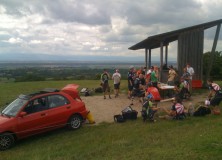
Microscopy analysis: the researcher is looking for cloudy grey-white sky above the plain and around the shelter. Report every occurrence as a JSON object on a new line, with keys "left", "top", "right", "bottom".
{"left": 0, "top": 0, "right": 222, "bottom": 61}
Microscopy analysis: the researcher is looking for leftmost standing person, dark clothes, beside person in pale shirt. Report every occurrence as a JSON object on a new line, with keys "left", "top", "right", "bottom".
{"left": 101, "top": 69, "right": 111, "bottom": 99}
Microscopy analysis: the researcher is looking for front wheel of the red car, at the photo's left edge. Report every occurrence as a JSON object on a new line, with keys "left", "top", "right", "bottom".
{"left": 0, "top": 133, "right": 15, "bottom": 150}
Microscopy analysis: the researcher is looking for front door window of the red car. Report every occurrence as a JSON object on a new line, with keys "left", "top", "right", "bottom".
{"left": 24, "top": 97, "right": 48, "bottom": 114}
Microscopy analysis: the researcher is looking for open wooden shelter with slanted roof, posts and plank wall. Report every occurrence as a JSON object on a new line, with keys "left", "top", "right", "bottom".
{"left": 129, "top": 19, "right": 222, "bottom": 81}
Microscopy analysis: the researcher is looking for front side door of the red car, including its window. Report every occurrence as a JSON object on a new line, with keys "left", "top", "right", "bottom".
{"left": 17, "top": 97, "right": 48, "bottom": 137}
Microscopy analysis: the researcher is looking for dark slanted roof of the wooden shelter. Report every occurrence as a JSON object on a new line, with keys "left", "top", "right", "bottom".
{"left": 129, "top": 19, "right": 222, "bottom": 50}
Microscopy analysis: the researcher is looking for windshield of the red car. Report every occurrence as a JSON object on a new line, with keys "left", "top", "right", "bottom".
{"left": 2, "top": 95, "right": 28, "bottom": 117}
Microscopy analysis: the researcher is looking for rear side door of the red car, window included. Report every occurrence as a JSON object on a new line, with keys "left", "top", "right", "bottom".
{"left": 43, "top": 94, "right": 72, "bottom": 128}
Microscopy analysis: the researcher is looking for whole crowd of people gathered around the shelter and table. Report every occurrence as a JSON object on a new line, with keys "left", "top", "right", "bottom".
{"left": 101, "top": 64, "right": 222, "bottom": 121}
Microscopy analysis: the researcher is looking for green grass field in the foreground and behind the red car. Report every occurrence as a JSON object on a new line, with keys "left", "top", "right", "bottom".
{"left": 0, "top": 80, "right": 222, "bottom": 160}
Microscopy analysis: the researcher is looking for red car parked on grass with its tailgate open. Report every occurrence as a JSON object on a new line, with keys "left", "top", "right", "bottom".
{"left": 0, "top": 84, "right": 88, "bottom": 150}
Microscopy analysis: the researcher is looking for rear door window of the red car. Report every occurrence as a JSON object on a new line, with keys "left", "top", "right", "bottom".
{"left": 48, "top": 94, "right": 69, "bottom": 108}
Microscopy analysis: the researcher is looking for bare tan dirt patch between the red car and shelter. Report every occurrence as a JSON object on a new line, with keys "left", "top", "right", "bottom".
{"left": 81, "top": 93, "right": 207, "bottom": 124}
